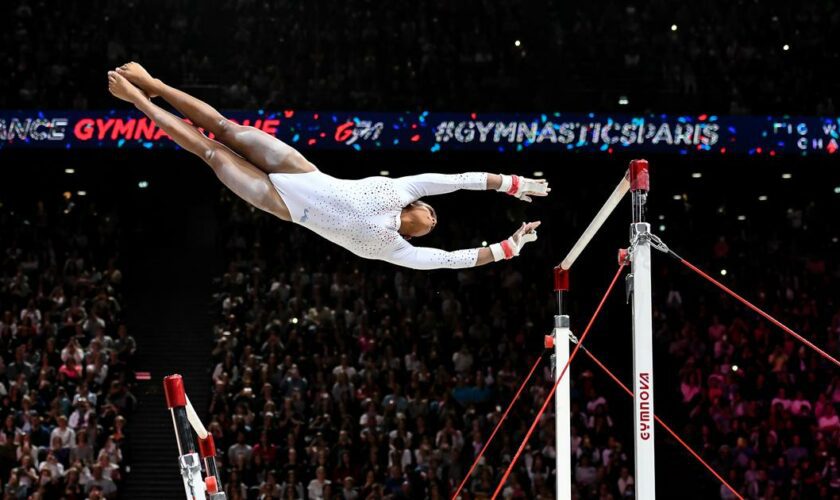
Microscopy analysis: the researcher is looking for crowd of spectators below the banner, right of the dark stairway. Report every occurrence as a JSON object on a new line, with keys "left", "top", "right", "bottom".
{"left": 200, "top": 177, "right": 840, "bottom": 500}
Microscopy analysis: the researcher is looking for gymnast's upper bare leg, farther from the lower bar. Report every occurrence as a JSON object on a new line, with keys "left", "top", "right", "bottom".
{"left": 117, "top": 62, "right": 317, "bottom": 174}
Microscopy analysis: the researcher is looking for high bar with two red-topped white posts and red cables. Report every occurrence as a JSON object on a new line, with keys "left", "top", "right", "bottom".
{"left": 451, "top": 155, "right": 840, "bottom": 500}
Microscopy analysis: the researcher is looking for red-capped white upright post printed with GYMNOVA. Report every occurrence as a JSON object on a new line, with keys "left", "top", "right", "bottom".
{"left": 630, "top": 160, "right": 656, "bottom": 499}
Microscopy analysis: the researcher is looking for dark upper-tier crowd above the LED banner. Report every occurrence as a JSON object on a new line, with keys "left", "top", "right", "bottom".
{"left": 0, "top": 0, "right": 840, "bottom": 114}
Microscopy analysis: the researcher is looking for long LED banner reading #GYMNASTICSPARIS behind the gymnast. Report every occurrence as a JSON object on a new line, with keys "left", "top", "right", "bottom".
{"left": 0, "top": 110, "right": 840, "bottom": 156}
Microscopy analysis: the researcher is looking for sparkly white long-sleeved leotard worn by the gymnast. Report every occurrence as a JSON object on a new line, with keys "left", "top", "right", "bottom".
{"left": 268, "top": 170, "right": 487, "bottom": 269}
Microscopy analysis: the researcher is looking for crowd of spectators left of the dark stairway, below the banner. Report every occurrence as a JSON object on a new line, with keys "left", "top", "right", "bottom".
{"left": 0, "top": 193, "right": 135, "bottom": 500}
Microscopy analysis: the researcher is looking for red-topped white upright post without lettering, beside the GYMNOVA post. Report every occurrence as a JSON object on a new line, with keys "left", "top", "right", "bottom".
{"left": 554, "top": 267, "right": 572, "bottom": 500}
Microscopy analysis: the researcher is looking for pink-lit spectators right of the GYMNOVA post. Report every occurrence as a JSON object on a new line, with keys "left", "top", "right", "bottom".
{"left": 655, "top": 197, "right": 840, "bottom": 499}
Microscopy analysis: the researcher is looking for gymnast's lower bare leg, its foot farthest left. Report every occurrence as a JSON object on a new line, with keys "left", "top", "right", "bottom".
{"left": 108, "top": 71, "right": 291, "bottom": 221}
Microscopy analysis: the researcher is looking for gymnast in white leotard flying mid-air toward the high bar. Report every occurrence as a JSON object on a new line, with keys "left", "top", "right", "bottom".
{"left": 108, "top": 62, "right": 551, "bottom": 269}
